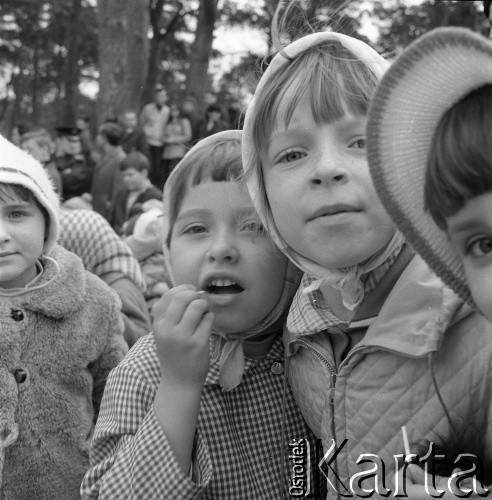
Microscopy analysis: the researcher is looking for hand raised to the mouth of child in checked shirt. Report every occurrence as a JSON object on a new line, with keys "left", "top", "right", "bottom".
{"left": 153, "top": 285, "right": 214, "bottom": 387}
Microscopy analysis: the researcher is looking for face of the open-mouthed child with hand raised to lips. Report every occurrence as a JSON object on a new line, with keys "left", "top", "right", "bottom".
{"left": 170, "top": 181, "right": 287, "bottom": 333}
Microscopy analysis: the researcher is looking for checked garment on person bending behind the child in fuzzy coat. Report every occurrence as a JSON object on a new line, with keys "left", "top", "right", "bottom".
{"left": 58, "top": 210, "right": 146, "bottom": 292}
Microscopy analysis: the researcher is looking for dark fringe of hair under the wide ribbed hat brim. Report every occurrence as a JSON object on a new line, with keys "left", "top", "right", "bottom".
{"left": 424, "top": 84, "right": 492, "bottom": 230}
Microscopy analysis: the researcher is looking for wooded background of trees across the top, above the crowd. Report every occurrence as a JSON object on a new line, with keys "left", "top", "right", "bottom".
{"left": 0, "top": 0, "right": 489, "bottom": 137}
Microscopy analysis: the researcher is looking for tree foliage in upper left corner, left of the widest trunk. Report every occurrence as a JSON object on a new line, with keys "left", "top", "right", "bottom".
{"left": 0, "top": 0, "right": 97, "bottom": 133}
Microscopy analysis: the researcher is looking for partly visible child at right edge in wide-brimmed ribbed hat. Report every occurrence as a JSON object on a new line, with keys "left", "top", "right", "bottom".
{"left": 367, "top": 27, "right": 492, "bottom": 496}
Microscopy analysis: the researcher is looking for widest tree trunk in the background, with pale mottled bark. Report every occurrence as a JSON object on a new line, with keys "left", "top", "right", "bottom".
{"left": 97, "top": 0, "right": 149, "bottom": 123}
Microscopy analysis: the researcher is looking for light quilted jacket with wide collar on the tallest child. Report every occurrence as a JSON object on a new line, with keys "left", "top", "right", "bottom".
{"left": 285, "top": 256, "right": 492, "bottom": 498}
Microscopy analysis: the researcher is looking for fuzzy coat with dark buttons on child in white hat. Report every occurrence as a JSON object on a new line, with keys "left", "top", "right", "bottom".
{"left": 0, "top": 246, "right": 127, "bottom": 500}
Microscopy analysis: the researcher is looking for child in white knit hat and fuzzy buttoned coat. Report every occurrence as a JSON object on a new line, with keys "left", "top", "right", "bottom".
{"left": 0, "top": 136, "right": 127, "bottom": 500}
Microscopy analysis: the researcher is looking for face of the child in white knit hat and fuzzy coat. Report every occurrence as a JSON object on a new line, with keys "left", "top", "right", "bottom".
{"left": 0, "top": 197, "right": 45, "bottom": 289}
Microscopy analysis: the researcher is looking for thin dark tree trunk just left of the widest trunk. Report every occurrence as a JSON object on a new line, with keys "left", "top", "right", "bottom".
{"left": 61, "top": 0, "right": 82, "bottom": 125}
